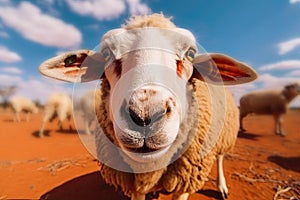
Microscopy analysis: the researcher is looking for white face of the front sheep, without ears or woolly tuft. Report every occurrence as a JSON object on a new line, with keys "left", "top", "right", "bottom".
{"left": 101, "top": 28, "right": 197, "bottom": 162}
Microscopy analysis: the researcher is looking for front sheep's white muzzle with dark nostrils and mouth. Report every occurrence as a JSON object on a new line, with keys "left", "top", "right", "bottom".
{"left": 110, "top": 84, "right": 180, "bottom": 161}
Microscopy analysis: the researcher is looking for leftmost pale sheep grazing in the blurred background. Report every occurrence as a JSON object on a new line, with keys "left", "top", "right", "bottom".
{"left": 10, "top": 96, "right": 39, "bottom": 122}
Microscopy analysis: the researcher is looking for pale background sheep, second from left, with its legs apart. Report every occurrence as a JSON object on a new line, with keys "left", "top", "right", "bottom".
{"left": 39, "top": 93, "right": 72, "bottom": 137}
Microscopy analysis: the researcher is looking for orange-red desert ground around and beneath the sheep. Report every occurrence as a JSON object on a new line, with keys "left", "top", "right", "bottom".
{"left": 0, "top": 109, "right": 300, "bottom": 200}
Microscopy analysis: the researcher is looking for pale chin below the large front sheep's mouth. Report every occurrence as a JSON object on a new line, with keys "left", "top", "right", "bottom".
{"left": 122, "top": 145, "right": 171, "bottom": 163}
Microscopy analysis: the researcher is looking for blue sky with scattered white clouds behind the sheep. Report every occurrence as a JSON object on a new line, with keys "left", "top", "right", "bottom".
{"left": 0, "top": 0, "right": 300, "bottom": 106}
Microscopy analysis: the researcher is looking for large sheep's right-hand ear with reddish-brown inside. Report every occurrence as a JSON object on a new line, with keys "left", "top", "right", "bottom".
{"left": 192, "top": 54, "right": 257, "bottom": 85}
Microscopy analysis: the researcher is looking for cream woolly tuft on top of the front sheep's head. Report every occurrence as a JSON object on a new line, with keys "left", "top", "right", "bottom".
{"left": 122, "top": 13, "right": 176, "bottom": 30}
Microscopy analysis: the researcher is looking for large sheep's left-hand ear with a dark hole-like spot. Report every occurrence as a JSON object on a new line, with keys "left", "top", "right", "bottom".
{"left": 39, "top": 49, "right": 106, "bottom": 83}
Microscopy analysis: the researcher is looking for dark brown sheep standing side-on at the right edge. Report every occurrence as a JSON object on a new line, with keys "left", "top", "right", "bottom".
{"left": 240, "top": 82, "right": 300, "bottom": 136}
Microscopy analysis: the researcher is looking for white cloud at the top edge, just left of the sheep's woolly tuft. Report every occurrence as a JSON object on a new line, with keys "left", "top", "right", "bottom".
{"left": 67, "top": 0, "right": 150, "bottom": 20}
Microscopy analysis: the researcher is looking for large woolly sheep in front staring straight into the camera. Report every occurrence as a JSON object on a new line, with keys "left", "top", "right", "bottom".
{"left": 39, "top": 14, "right": 257, "bottom": 200}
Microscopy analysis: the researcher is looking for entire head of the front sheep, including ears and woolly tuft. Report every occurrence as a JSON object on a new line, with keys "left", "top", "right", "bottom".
{"left": 40, "top": 14, "right": 256, "bottom": 172}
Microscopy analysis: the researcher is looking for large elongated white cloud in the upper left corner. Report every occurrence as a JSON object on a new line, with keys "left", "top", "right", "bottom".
{"left": 0, "top": 1, "right": 82, "bottom": 48}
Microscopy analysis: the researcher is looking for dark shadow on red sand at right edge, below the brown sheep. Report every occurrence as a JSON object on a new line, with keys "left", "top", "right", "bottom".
{"left": 268, "top": 155, "right": 300, "bottom": 172}
